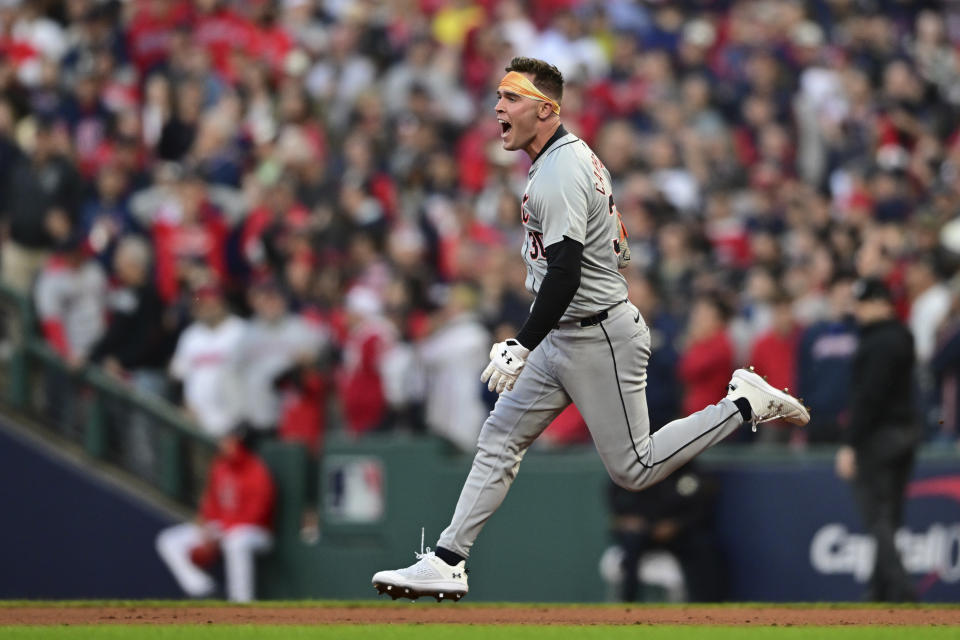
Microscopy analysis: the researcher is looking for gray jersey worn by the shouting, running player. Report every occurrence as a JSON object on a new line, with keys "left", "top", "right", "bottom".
{"left": 521, "top": 133, "right": 627, "bottom": 321}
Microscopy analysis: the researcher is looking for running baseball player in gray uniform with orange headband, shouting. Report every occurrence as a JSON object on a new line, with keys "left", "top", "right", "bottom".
{"left": 373, "top": 58, "right": 809, "bottom": 601}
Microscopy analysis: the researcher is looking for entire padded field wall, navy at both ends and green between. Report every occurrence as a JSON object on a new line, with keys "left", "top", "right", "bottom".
{"left": 0, "top": 416, "right": 960, "bottom": 602}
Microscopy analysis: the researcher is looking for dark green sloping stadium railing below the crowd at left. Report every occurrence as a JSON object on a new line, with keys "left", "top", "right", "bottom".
{"left": 0, "top": 283, "right": 216, "bottom": 507}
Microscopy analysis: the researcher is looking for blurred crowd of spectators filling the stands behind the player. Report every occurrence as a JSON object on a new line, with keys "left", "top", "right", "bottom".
{"left": 0, "top": 0, "right": 960, "bottom": 451}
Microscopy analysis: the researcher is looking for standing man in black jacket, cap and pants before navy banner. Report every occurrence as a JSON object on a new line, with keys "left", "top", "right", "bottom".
{"left": 836, "top": 279, "right": 920, "bottom": 602}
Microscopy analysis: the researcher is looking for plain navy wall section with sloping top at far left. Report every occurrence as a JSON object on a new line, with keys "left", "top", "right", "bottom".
{"left": 0, "top": 420, "right": 182, "bottom": 599}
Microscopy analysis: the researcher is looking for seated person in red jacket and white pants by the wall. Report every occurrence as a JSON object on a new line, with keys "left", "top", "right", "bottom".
{"left": 157, "top": 427, "right": 276, "bottom": 602}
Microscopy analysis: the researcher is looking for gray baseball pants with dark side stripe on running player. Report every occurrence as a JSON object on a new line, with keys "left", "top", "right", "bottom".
{"left": 437, "top": 303, "right": 743, "bottom": 557}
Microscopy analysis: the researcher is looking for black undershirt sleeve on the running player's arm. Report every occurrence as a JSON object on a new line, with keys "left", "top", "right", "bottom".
{"left": 516, "top": 236, "right": 583, "bottom": 351}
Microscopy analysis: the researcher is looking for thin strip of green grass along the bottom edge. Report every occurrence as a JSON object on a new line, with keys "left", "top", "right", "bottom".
{"left": 0, "top": 625, "right": 960, "bottom": 640}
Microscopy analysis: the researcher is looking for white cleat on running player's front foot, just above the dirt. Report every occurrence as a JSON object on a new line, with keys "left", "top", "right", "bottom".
{"left": 372, "top": 547, "right": 468, "bottom": 602}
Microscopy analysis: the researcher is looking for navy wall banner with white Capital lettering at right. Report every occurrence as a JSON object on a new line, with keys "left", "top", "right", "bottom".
{"left": 716, "top": 461, "right": 960, "bottom": 602}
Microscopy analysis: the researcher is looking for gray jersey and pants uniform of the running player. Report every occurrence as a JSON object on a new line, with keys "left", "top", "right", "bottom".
{"left": 438, "top": 129, "right": 743, "bottom": 557}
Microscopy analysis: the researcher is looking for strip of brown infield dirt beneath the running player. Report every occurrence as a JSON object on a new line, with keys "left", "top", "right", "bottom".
{"left": 0, "top": 602, "right": 960, "bottom": 627}
